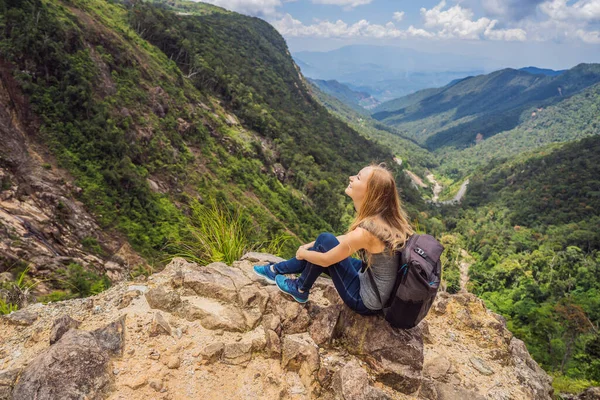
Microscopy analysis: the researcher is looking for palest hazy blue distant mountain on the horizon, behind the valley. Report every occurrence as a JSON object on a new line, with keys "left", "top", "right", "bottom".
{"left": 293, "top": 45, "right": 500, "bottom": 101}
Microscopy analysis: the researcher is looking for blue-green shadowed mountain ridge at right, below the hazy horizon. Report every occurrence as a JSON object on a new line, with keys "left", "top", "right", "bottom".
{"left": 373, "top": 64, "right": 600, "bottom": 149}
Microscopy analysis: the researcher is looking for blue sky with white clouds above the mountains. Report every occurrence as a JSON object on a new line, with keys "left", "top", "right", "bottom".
{"left": 203, "top": 0, "right": 600, "bottom": 69}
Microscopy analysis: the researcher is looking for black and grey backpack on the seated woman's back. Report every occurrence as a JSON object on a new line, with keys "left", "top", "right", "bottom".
{"left": 367, "top": 234, "right": 444, "bottom": 329}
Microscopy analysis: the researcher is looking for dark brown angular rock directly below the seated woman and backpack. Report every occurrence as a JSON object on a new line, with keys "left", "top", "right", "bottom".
{"left": 334, "top": 306, "right": 423, "bottom": 394}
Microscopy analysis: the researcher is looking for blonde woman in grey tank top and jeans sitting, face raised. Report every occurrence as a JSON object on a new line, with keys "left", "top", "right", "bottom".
{"left": 254, "top": 165, "right": 413, "bottom": 314}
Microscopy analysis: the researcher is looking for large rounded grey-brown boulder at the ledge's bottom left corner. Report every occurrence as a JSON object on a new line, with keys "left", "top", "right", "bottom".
{"left": 13, "top": 329, "right": 114, "bottom": 400}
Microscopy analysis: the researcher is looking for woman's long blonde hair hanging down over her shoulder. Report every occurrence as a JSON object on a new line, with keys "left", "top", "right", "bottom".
{"left": 348, "top": 164, "right": 414, "bottom": 266}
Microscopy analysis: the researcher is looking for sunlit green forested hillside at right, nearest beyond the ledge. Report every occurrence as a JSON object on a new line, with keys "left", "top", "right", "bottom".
{"left": 444, "top": 136, "right": 600, "bottom": 381}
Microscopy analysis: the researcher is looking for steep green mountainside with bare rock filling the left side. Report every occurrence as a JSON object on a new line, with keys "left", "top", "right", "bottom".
{"left": 0, "top": 0, "right": 393, "bottom": 300}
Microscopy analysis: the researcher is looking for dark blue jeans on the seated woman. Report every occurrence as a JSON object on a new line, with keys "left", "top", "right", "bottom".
{"left": 273, "top": 233, "right": 378, "bottom": 315}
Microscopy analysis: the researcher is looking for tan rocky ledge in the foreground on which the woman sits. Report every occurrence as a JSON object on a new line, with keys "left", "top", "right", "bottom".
{"left": 0, "top": 253, "right": 552, "bottom": 400}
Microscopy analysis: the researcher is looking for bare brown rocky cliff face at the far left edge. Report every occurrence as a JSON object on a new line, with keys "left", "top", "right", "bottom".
{"left": 0, "top": 63, "right": 144, "bottom": 294}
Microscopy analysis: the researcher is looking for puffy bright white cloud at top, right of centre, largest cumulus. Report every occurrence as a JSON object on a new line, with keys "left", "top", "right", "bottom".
{"left": 421, "top": 0, "right": 527, "bottom": 41}
